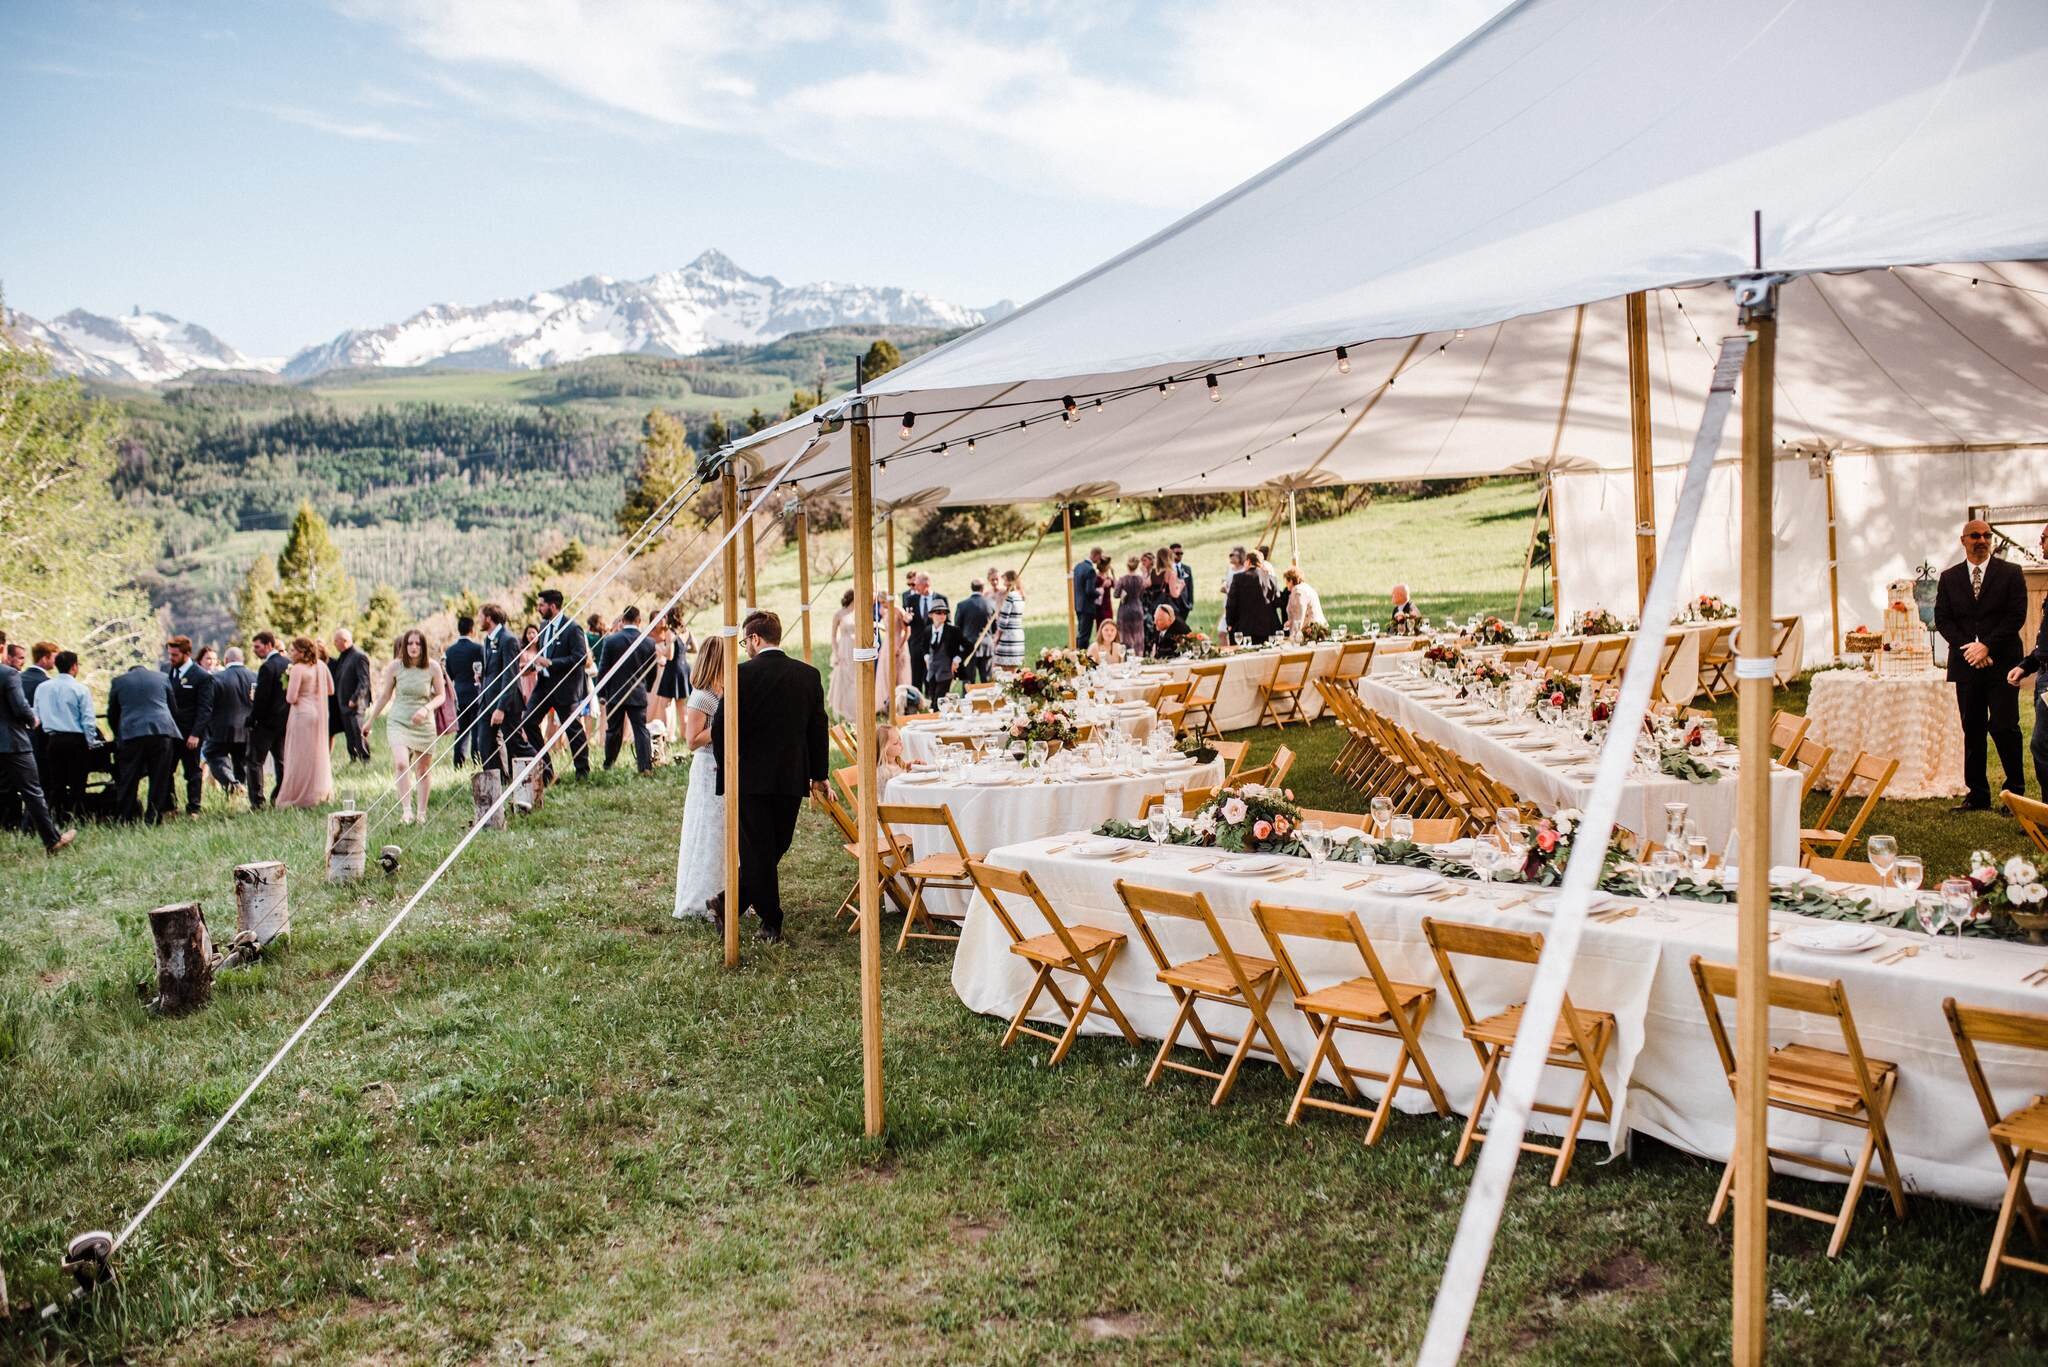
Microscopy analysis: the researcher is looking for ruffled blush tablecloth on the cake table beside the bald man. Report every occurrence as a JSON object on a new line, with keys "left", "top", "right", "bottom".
{"left": 1806, "top": 670, "right": 1970, "bottom": 797}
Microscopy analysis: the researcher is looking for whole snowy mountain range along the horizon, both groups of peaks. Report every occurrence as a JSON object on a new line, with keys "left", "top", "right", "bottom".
{"left": 4, "top": 250, "right": 1012, "bottom": 385}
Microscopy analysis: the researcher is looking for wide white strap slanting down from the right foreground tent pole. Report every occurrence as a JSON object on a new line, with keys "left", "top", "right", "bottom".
{"left": 1417, "top": 334, "right": 1757, "bottom": 1367}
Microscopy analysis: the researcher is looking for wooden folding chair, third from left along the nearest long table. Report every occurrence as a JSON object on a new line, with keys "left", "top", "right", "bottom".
{"left": 1251, "top": 902, "right": 1450, "bottom": 1148}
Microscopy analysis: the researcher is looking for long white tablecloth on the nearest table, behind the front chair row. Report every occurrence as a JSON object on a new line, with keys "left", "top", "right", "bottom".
{"left": 952, "top": 840, "right": 2048, "bottom": 1205}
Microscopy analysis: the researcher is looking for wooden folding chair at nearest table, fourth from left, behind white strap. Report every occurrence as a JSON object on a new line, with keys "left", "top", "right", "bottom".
{"left": 1421, "top": 916, "right": 1614, "bottom": 1187}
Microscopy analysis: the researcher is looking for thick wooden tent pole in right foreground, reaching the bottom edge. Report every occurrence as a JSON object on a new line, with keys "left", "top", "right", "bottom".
{"left": 1733, "top": 285, "right": 1778, "bottom": 1363}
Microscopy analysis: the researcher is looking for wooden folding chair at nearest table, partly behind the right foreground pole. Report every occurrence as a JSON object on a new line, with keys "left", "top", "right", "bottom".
{"left": 1692, "top": 955, "right": 1907, "bottom": 1258}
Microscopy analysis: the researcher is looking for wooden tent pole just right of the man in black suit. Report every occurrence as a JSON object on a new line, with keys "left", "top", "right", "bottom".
{"left": 843, "top": 404, "right": 883, "bottom": 1140}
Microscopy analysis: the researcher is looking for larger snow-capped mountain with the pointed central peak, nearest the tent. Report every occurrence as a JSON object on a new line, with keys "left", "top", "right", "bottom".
{"left": 285, "top": 250, "right": 985, "bottom": 379}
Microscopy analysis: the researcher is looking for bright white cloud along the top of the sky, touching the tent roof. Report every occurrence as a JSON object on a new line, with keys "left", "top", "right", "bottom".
{"left": 338, "top": 0, "right": 1499, "bottom": 207}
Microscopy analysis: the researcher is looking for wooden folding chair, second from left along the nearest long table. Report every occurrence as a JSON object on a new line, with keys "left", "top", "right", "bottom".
{"left": 1116, "top": 879, "right": 1294, "bottom": 1107}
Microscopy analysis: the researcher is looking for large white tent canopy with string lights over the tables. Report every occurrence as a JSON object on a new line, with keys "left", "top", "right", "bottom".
{"left": 745, "top": 0, "right": 2048, "bottom": 512}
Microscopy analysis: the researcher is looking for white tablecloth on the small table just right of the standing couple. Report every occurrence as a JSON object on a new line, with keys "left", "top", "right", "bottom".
{"left": 883, "top": 758, "right": 1223, "bottom": 914}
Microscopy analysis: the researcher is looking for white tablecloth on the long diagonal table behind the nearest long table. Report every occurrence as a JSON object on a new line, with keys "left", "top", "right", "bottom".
{"left": 1358, "top": 678, "right": 1800, "bottom": 865}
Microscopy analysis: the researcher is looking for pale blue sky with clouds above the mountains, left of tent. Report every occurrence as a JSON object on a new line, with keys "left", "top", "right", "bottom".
{"left": 0, "top": 0, "right": 1497, "bottom": 355}
